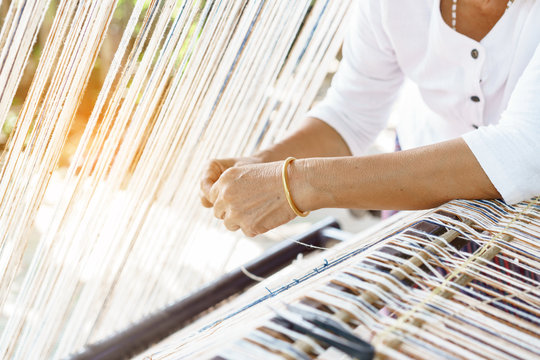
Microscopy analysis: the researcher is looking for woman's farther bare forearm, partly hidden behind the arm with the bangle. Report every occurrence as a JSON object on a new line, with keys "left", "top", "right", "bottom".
{"left": 254, "top": 118, "right": 351, "bottom": 162}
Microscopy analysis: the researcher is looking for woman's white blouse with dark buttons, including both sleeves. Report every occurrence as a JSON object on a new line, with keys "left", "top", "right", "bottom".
{"left": 308, "top": 0, "right": 540, "bottom": 203}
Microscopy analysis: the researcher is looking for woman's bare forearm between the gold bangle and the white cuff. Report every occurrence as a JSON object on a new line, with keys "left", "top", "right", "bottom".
{"left": 289, "top": 139, "right": 500, "bottom": 210}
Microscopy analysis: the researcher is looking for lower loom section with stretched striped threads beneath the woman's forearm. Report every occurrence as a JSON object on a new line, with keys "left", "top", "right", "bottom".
{"left": 140, "top": 198, "right": 540, "bottom": 360}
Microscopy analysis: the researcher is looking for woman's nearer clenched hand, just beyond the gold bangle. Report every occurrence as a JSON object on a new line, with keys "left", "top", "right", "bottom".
{"left": 209, "top": 162, "right": 295, "bottom": 237}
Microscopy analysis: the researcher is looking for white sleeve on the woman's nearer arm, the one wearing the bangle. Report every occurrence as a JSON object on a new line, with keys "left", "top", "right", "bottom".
{"left": 463, "top": 46, "right": 540, "bottom": 204}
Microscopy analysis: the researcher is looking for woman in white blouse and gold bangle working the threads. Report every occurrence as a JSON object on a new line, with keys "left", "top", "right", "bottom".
{"left": 201, "top": 0, "right": 540, "bottom": 236}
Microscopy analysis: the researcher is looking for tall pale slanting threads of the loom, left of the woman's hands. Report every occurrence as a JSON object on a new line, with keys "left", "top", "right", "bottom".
{"left": 0, "top": 0, "right": 349, "bottom": 359}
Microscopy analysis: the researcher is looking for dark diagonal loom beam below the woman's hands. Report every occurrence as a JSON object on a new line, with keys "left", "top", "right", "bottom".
{"left": 69, "top": 218, "right": 342, "bottom": 360}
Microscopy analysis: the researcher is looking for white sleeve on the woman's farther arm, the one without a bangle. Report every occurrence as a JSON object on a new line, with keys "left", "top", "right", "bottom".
{"left": 307, "top": 0, "right": 403, "bottom": 155}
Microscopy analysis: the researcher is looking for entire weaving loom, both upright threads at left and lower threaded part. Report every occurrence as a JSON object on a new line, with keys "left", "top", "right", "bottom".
{"left": 0, "top": 0, "right": 540, "bottom": 359}
